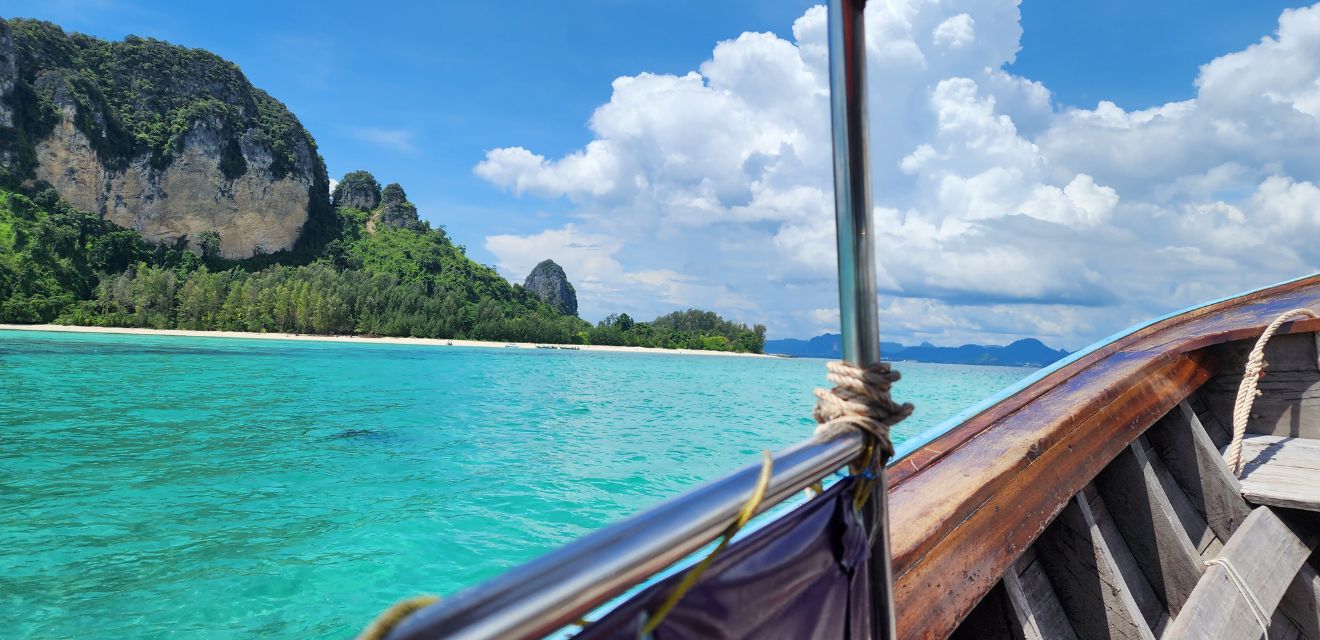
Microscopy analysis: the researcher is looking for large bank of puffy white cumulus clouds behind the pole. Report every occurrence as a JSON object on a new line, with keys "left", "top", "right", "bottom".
{"left": 475, "top": 0, "right": 1320, "bottom": 348}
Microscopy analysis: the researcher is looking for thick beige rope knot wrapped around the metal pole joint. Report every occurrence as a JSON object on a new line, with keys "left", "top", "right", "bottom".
{"left": 812, "top": 362, "right": 912, "bottom": 458}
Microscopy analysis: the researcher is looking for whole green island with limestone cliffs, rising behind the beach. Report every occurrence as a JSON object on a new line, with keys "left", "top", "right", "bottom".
{"left": 0, "top": 18, "right": 766, "bottom": 352}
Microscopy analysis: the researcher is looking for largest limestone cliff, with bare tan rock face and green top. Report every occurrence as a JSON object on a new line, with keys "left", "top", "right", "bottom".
{"left": 0, "top": 20, "right": 333, "bottom": 259}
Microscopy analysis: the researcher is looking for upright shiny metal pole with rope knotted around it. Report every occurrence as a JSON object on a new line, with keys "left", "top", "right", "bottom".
{"left": 829, "top": 0, "right": 896, "bottom": 640}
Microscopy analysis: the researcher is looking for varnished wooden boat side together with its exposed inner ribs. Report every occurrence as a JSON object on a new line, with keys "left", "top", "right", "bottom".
{"left": 908, "top": 276, "right": 1320, "bottom": 640}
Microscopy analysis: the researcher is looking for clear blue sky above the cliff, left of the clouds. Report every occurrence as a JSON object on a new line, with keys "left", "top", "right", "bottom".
{"left": 0, "top": 0, "right": 810, "bottom": 255}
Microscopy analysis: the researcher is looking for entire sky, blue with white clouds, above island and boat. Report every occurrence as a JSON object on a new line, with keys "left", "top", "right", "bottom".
{"left": 3, "top": 0, "right": 1320, "bottom": 348}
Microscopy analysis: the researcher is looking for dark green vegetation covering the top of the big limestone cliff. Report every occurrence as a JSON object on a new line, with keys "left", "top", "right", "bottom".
{"left": 0, "top": 18, "right": 315, "bottom": 179}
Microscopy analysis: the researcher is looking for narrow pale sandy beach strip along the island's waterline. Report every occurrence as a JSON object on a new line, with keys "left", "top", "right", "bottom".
{"left": 0, "top": 323, "right": 779, "bottom": 359}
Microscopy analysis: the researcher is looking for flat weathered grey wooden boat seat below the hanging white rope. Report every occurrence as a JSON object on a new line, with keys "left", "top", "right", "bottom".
{"left": 1241, "top": 434, "right": 1320, "bottom": 511}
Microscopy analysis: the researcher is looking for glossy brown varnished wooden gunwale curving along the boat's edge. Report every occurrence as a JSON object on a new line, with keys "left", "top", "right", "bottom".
{"left": 890, "top": 274, "right": 1320, "bottom": 637}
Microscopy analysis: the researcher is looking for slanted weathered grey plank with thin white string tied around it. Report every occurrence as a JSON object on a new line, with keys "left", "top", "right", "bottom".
{"left": 1164, "top": 507, "right": 1320, "bottom": 640}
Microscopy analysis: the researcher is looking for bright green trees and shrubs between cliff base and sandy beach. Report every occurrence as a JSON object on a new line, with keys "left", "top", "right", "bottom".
{"left": 0, "top": 183, "right": 766, "bottom": 352}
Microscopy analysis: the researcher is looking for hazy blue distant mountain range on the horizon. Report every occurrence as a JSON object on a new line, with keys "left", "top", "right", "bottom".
{"left": 766, "top": 334, "right": 1068, "bottom": 367}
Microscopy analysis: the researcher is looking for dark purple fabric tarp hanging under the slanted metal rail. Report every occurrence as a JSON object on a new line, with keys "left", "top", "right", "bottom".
{"left": 576, "top": 478, "right": 870, "bottom": 640}
